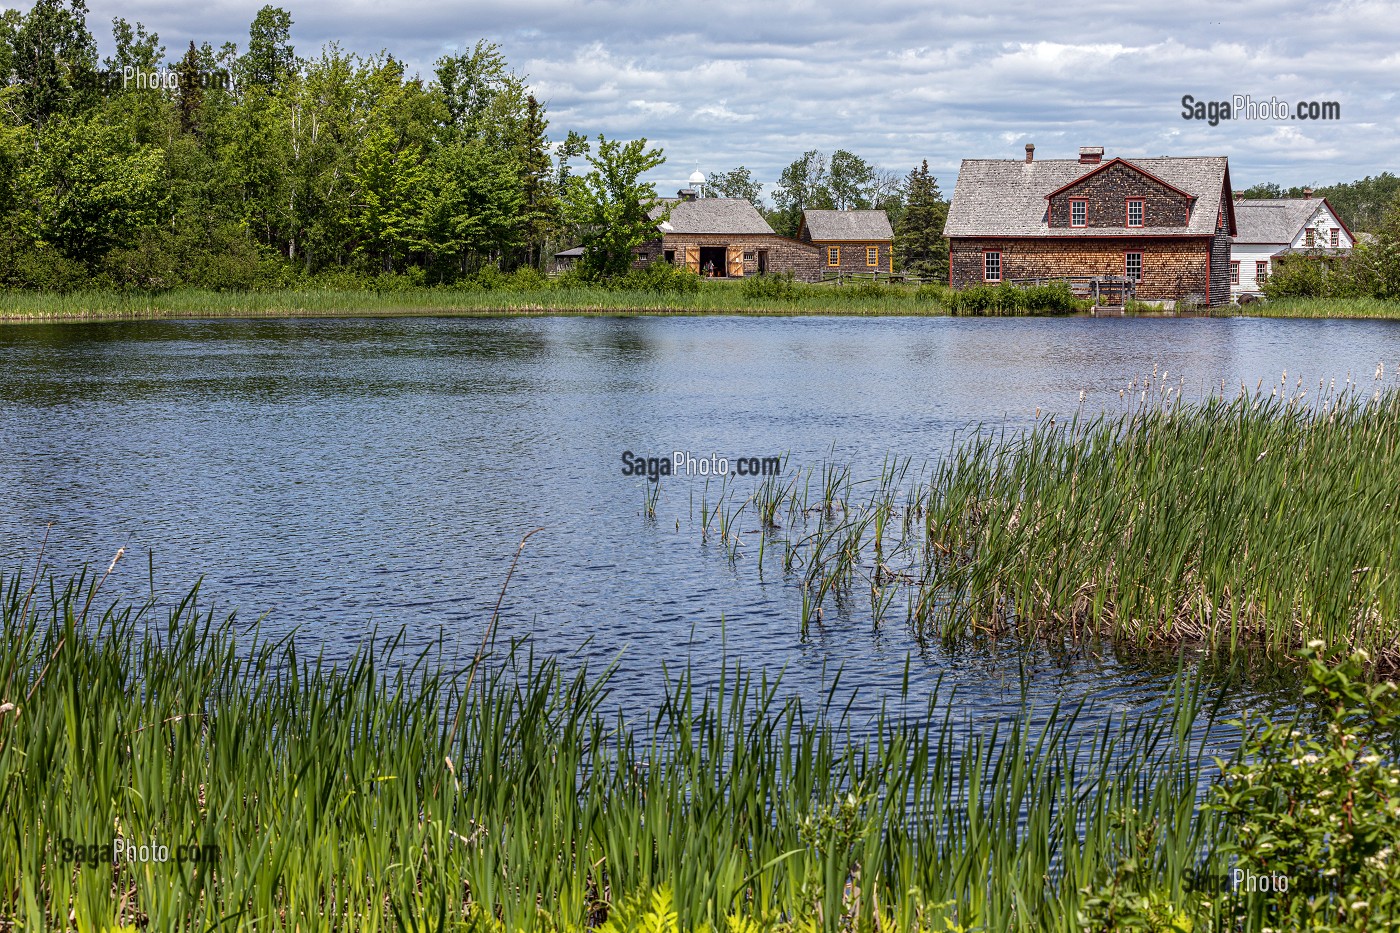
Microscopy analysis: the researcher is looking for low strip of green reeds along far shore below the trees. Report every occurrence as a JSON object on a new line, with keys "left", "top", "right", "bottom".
{"left": 0, "top": 282, "right": 946, "bottom": 321}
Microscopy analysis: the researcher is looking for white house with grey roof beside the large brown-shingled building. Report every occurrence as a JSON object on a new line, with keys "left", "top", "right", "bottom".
{"left": 1229, "top": 189, "right": 1357, "bottom": 298}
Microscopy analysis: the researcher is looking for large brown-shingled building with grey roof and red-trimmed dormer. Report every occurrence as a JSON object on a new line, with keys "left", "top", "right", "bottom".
{"left": 944, "top": 146, "right": 1235, "bottom": 305}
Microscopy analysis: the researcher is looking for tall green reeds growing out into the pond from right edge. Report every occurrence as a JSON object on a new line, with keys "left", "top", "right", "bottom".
{"left": 714, "top": 370, "right": 1400, "bottom": 675}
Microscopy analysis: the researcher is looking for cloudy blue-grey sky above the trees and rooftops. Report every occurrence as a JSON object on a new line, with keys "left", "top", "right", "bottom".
{"left": 76, "top": 0, "right": 1400, "bottom": 201}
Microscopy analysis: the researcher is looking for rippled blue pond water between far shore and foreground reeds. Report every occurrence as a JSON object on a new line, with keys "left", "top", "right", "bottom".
{"left": 0, "top": 317, "right": 1400, "bottom": 720}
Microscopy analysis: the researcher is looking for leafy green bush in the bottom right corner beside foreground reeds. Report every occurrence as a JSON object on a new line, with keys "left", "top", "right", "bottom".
{"left": 1212, "top": 640, "right": 1400, "bottom": 930}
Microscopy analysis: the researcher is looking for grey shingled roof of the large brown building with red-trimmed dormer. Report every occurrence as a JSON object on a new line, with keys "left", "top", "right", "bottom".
{"left": 944, "top": 156, "right": 1229, "bottom": 237}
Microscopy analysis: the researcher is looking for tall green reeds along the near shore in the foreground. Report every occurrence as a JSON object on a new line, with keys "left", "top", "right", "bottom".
{"left": 0, "top": 563, "right": 1243, "bottom": 932}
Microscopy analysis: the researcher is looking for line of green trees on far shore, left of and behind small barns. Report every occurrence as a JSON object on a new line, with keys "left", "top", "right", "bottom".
{"left": 0, "top": 0, "right": 946, "bottom": 289}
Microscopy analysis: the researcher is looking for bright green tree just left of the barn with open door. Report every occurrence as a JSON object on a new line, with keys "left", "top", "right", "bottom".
{"left": 566, "top": 134, "right": 669, "bottom": 277}
